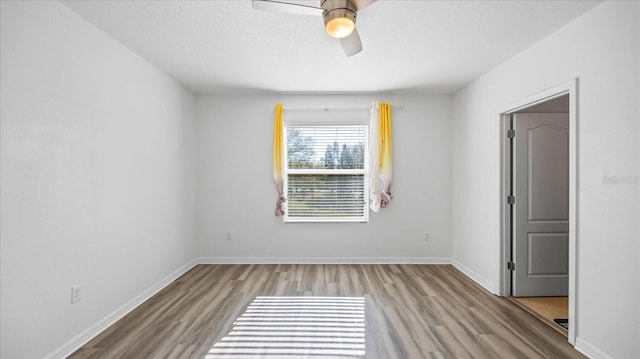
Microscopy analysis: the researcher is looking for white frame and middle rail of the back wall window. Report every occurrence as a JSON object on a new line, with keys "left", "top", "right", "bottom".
{"left": 283, "top": 123, "right": 369, "bottom": 223}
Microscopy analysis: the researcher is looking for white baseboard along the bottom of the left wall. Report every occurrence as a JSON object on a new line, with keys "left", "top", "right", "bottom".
{"left": 45, "top": 259, "right": 197, "bottom": 359}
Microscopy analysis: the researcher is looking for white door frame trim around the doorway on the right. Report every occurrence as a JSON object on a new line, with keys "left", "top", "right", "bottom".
{"left": 498, "top": 78, "right": 578, "bottom": 346}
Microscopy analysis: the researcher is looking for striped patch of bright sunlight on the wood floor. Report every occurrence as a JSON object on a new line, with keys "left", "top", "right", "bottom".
{"left": 205, "top": 296, "right": 365, "bottom": 359}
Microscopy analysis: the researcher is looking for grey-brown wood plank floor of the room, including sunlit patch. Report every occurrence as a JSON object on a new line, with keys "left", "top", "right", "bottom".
{"left": 71, "top": 265, "right": 584, "bottom": 359}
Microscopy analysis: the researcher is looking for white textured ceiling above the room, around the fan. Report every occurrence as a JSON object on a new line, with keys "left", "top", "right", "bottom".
{"left": 63, "top": 0, "right": 599, "bottom": 93}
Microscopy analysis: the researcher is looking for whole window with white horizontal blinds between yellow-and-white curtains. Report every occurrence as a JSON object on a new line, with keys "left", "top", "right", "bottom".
{"left": 284, "top": 125, "right": 369, "bottom": 222}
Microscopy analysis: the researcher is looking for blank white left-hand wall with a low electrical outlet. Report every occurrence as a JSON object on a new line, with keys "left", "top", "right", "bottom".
{"left": 0, "top": 1, "right": 197, "bottom": 359}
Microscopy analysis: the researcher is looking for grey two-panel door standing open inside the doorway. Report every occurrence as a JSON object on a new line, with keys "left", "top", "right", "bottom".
{"left": 512, "top": 113, "right": 569, "bottom": 297}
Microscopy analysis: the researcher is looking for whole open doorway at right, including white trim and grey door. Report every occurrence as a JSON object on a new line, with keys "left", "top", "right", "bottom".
{"left": 500, "top": 80, "right": 577, "bottom": 345}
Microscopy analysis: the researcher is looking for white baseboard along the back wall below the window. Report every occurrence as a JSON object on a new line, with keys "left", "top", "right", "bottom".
{"left": 198, "top": 257, "right": 451, "bottom": 264}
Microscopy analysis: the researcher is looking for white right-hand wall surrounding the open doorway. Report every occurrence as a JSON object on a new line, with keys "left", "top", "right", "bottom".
{"left": 452, "top": 1, "right": 640, "bottom": 358}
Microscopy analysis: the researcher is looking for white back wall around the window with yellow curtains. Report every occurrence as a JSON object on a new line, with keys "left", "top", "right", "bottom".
{"left": 197, "top": 94, "right": 451, "bottom": 262}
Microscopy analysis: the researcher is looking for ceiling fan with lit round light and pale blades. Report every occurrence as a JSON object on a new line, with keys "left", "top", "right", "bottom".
{"left": 251, "top": 0, "right": 376, "bottom": 57}
